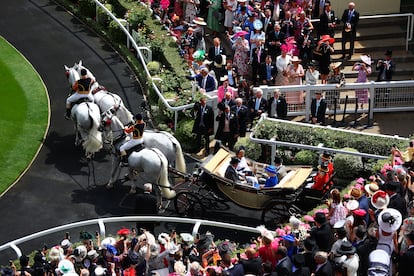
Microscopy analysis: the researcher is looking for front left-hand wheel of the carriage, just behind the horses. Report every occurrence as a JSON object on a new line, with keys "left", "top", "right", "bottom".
{"left": 174, "top": 192, "right": 204, "bottom": 218}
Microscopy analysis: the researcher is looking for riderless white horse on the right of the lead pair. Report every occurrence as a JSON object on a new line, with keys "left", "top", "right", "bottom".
{"left": 73, "top": 60, "right": 133, "bottom": 125}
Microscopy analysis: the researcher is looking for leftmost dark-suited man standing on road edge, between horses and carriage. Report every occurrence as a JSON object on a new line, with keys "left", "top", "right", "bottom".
{"left": 193, "top": 97, "right": 214, "bottom": 155}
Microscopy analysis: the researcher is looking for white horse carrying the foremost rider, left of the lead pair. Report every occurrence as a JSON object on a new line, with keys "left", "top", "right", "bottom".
{"left": 65, "top": 66, "right": 102, "bottom": 158}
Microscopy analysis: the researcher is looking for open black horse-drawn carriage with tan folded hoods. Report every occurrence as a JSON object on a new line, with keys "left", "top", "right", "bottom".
{"left": 174, "top": 148, "right": 332, "bottom": 226}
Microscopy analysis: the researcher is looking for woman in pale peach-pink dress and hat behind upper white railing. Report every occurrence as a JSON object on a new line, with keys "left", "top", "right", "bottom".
{"left": 286, "top": 56, "right": 305, "bottom": 104}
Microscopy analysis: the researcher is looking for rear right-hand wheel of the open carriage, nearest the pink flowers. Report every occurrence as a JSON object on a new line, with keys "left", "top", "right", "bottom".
{"left": 262, "top": 202, "right": 290, "bottom": 229}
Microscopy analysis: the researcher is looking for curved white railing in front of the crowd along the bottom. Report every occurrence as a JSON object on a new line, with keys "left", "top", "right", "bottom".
{"left": 0, "top": 216, "right": 260, "bottom": 258}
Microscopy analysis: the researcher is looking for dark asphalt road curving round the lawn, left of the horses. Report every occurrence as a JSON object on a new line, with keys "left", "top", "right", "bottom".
{"left": 0, "top": 0, "right": 148, "bottom": 258}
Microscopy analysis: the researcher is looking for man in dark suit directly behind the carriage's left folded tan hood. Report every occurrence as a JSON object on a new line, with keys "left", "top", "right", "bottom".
{"left": 214, "top": 105, "right": 239, "bottom": 151}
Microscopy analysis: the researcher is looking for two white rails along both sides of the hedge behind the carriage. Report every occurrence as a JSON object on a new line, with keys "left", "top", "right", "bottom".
{"left": 249, "top": 114, "right": 409, "bottom": 165}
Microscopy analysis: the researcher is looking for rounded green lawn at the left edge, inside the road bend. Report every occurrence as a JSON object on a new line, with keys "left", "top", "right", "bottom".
{"left": 0, "top": 37, "right": 49, "bottom": 194}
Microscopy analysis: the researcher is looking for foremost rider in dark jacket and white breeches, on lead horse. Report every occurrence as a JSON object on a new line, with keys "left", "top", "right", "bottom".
{"left": 65, "top": 69, "right": 94, "bottom": 120}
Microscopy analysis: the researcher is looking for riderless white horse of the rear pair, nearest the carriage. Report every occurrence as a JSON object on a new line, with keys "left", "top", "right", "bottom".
{"left": 102, "top": 110, "right": 187, "bottom": 173}
